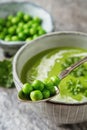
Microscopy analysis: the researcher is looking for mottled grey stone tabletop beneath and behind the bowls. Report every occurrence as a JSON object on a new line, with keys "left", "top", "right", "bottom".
{"left": 0, "top": 0, "right": 87, "bottom": 130}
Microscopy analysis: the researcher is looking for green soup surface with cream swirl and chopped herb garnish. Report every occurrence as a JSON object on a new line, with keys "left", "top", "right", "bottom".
{"left": 21, "top": 47, "right": 87, "bottom": 102}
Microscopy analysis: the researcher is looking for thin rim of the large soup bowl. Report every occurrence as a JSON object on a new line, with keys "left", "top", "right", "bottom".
{"left": 12, "top": 31, "right": 87, "bottom": 106}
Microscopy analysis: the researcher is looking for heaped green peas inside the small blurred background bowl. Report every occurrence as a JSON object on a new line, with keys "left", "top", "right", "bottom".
{"left": 0, "top": 12, "right": 46, "bottom": 41}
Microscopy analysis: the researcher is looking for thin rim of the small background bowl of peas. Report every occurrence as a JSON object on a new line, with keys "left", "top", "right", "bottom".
{"left": 0, "top": 1, "right": 55, "bottom": 46}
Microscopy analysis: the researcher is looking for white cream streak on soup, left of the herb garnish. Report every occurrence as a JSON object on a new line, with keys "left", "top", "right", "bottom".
{"left": 36, "top": 50, "right": 69, "bottom": 80}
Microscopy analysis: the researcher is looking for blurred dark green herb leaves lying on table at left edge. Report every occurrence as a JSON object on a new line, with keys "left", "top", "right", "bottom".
{"left": 0, "top": 59, "right": 14, "bottom": 88}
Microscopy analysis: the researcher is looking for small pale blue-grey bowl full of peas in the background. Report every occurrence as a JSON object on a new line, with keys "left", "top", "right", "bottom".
{"left": 0, "top": 2, "right": 54, "bottom": 56}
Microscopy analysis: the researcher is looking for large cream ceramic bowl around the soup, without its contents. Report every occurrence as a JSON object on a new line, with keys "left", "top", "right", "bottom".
{"left": 13, "top": 32, "right": 87, "bottom": 125}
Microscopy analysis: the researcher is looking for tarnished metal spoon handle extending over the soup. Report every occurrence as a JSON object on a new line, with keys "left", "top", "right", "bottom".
{"left": 59, "top": 56, "right": 87, "bottom": 79}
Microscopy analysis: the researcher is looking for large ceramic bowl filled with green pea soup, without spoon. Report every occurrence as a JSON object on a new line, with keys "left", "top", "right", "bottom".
{"left": 13, "top": 31, "right": 87, "bottom": 125}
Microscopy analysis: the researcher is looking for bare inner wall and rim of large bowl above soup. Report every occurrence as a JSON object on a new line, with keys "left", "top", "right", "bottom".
{"left": 13, "top": 32, "right": 87, "bottom": 102}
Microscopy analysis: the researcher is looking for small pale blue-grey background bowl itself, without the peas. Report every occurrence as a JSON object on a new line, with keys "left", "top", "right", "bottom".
{"left": 0, "top": 2, "right": 54, "bottom": 55}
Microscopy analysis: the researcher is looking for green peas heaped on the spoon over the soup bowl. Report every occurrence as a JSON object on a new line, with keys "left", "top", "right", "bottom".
{"left": 18, "top": 76, "right": 60, "bottom": 101}
